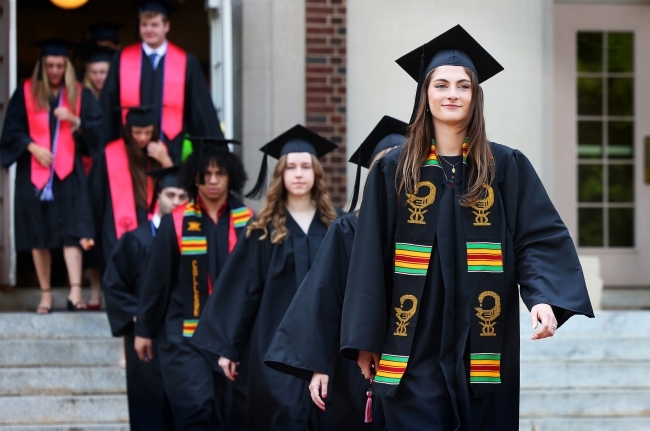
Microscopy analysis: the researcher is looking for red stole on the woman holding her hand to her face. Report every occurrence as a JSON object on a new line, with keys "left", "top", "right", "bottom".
{"left": 104, "top": 138, "right": 154, "bottom": 239}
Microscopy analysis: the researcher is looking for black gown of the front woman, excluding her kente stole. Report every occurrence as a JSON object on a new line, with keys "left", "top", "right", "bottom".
{"left": 341, "top": 144, "right": 593, "bottom": 431}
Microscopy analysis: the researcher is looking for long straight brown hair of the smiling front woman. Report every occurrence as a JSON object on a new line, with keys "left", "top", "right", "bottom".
{"left": 395, "top": 67, "right": 494, "bottom": 206}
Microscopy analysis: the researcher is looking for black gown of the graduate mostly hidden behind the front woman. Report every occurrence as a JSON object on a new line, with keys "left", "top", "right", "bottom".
{"left": 264, "top": 213, "right": 385, "bottom": 431}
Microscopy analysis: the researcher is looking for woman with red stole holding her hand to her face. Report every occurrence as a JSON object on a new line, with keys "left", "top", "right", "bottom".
{"left": 73, "top": 107, "right": 173, "bottom": 272}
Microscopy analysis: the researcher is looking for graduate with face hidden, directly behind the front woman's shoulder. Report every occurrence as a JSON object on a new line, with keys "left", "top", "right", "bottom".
{"left": 264, "top": 116, "right": 407, "bottom": 431}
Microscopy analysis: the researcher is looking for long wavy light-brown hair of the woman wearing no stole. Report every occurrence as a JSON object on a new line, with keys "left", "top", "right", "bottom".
{"left": 246, "top": 155, "right": 337, "bottom": 244}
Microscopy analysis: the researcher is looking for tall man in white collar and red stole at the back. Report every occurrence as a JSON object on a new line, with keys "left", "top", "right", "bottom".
{"left": 100, "top": 0, "right": 223, "bottom": 164}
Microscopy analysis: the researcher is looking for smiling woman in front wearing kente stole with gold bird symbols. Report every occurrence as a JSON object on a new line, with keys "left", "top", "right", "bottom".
{"left": 341, "top": 26, "right": 593, "bottom": 431}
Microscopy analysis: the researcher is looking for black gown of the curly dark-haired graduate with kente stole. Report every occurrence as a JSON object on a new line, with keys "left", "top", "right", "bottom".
{"left": 135, "top": 207, "right": 235, "bottom": 430}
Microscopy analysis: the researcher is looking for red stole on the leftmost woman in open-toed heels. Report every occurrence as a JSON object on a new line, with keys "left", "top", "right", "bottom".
{"left": 23, "top": 79, "right": 81, "bottom": 190}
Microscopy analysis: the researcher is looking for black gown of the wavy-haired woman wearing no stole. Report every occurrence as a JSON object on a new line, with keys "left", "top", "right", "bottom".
{"left": 192, "top": 213, "right": 342, "bottom": 431}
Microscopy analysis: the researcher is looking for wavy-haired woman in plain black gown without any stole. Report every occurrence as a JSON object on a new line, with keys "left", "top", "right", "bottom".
{"left": 193, "top": 125, "right": 337, "bottom": 431}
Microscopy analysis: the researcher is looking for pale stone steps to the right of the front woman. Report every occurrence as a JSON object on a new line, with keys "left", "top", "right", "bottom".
{"left": 519, "top": 311, "right": 650, "bottom": 431}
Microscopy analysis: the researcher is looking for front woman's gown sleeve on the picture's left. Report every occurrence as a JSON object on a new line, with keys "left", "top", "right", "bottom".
{"left": 341, "top": 155, "right": 399, "bottom": 360}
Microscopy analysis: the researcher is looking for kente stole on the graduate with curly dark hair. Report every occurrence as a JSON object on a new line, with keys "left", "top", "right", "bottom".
{"left": 172, "top": 196, "right": 253, "bottom": 337}
